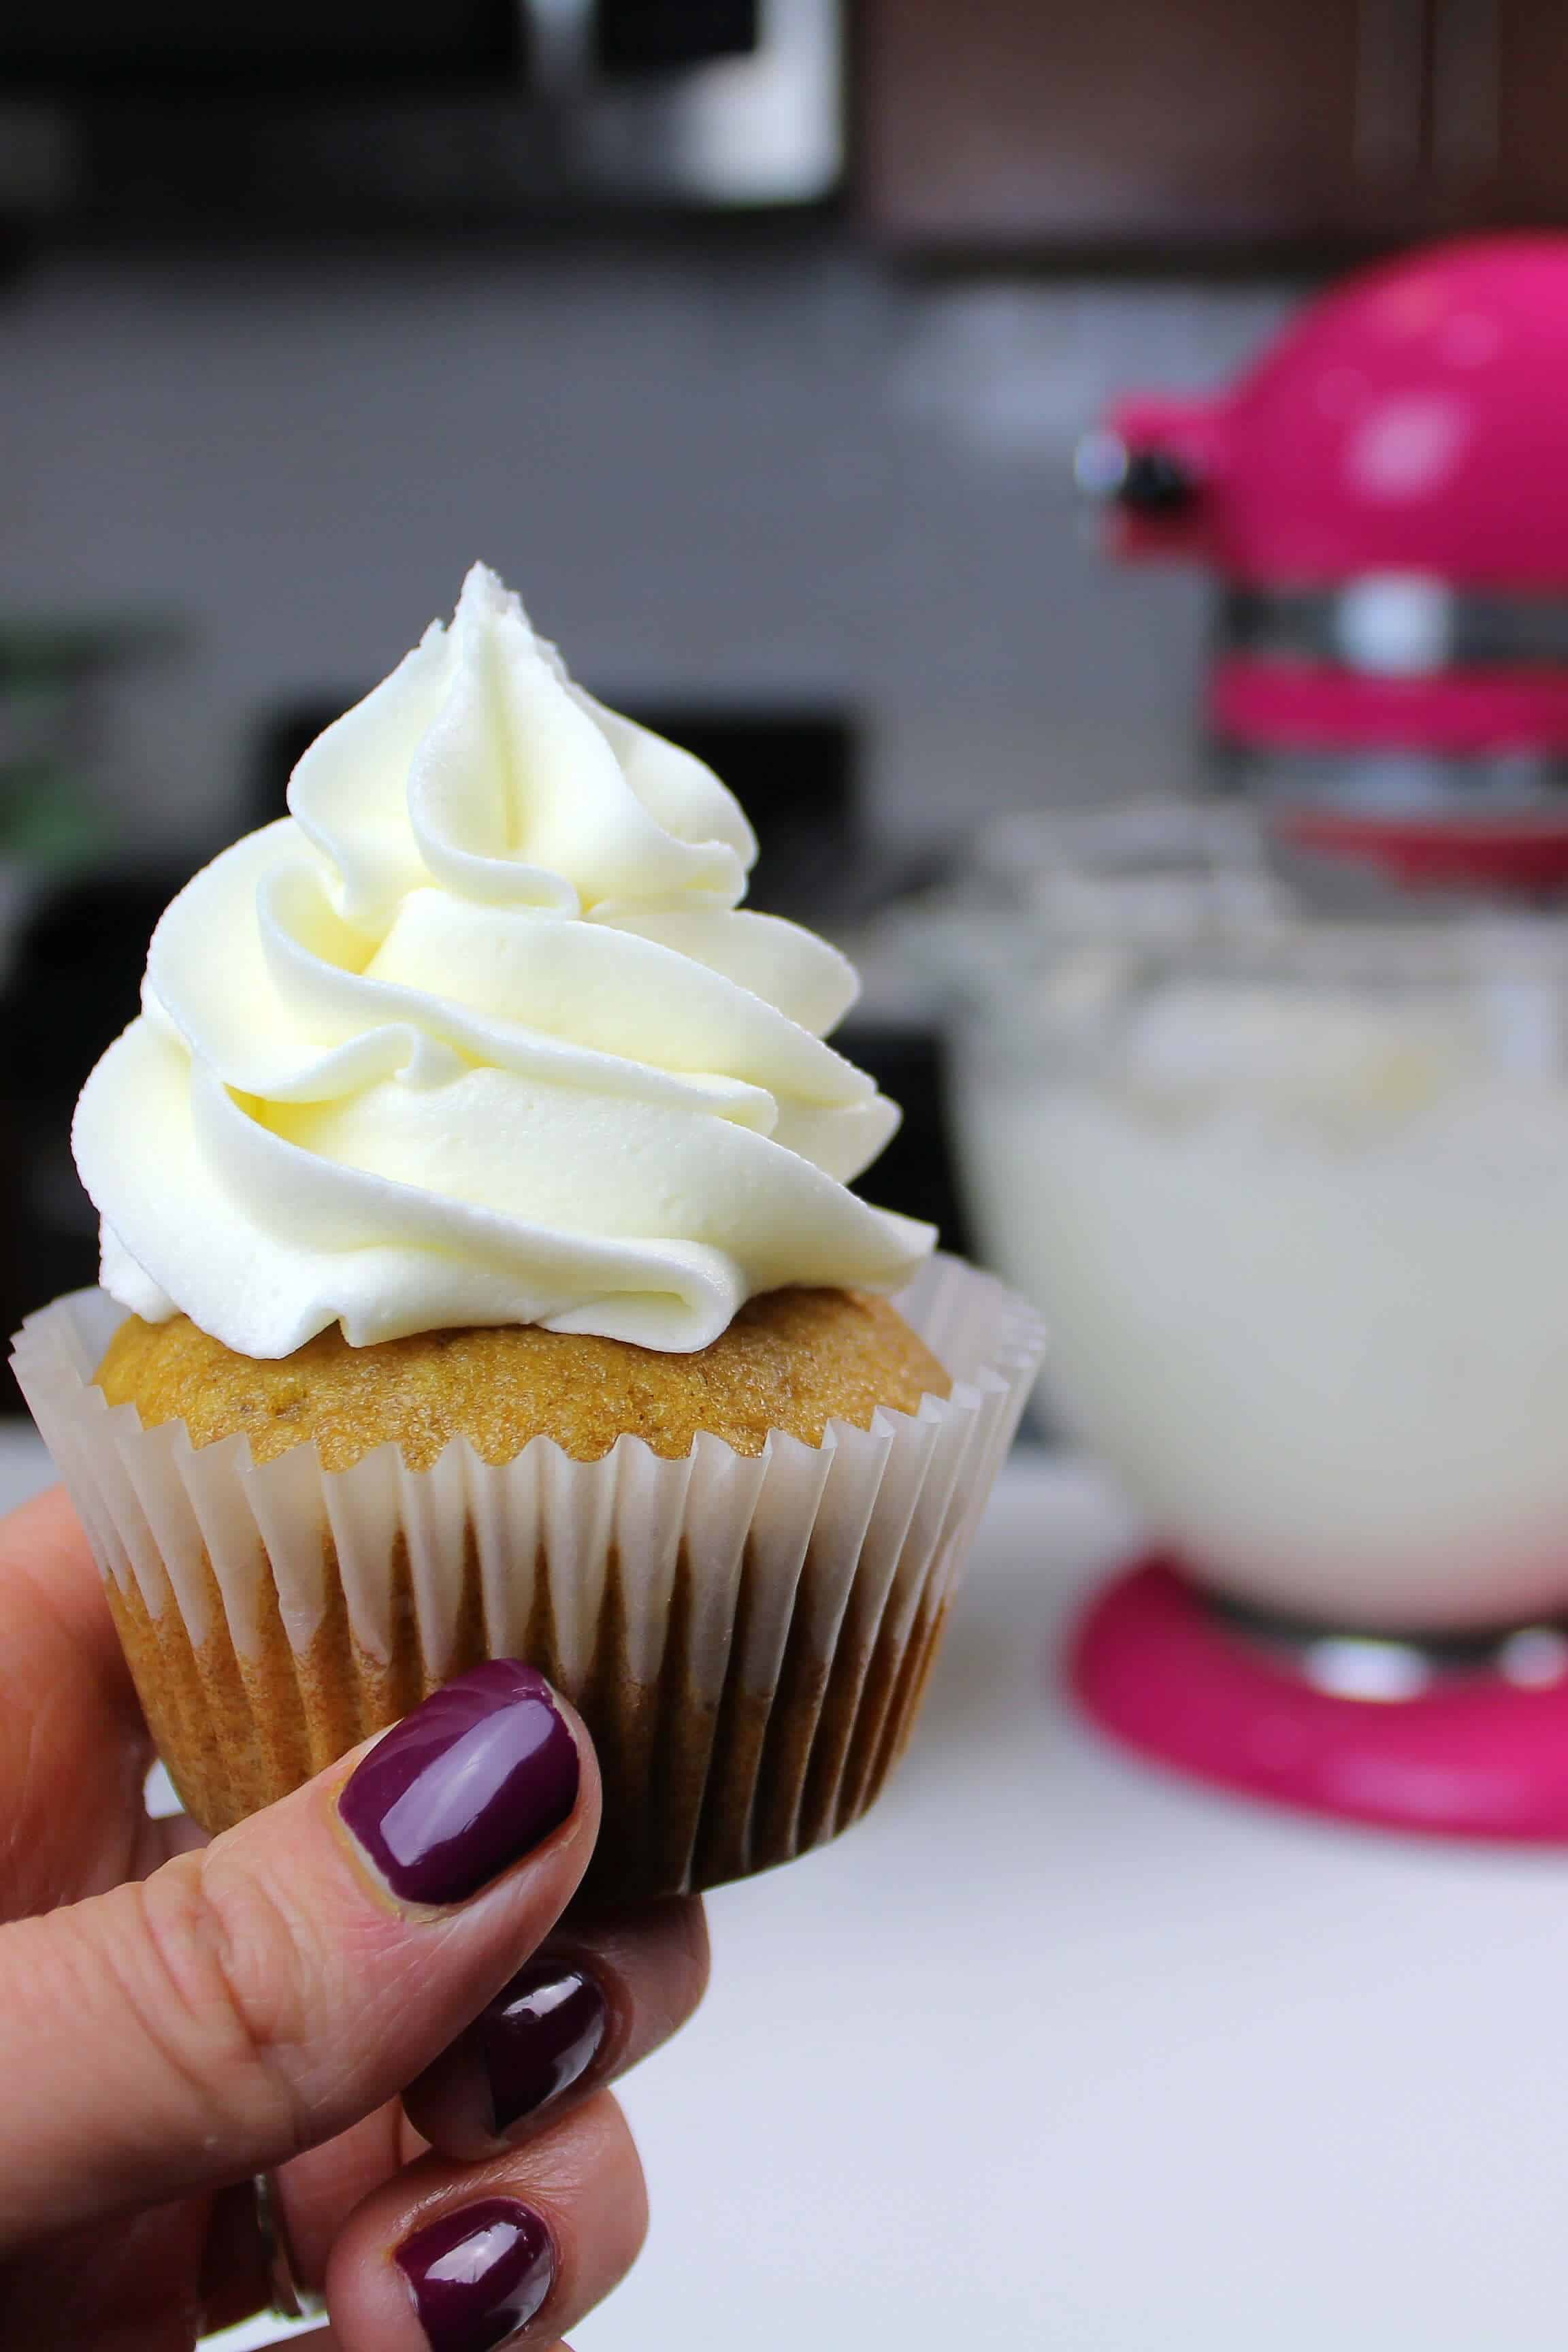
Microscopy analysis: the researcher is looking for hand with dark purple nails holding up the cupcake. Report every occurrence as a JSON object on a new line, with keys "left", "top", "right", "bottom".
{"left": 0, "top": 1491, "right": 708, "bottom": 2352}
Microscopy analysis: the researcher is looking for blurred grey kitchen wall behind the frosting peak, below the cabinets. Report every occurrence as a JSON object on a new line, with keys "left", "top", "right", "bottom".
{"left": 0, "top": 231, "right": 1288, "bottom": 860}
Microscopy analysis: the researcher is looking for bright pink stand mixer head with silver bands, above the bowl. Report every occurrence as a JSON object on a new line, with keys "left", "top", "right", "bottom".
{"left": 1079, "top": 235, "right": 1568, "bottom": 894}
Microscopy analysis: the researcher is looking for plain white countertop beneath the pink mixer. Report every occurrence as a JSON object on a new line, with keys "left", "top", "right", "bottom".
{"left": 0, "top": 1439, "right": 1568, "bottom": 2352}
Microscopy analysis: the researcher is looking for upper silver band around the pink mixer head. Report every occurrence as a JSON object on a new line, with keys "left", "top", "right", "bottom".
{"left": 1218, "top": 572, "right": 1568, "bottom": 677}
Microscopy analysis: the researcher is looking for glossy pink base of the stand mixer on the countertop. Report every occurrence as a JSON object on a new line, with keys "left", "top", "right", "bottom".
{"left": 1070, "top": 1559, "right": 1568, "bottom": 1844}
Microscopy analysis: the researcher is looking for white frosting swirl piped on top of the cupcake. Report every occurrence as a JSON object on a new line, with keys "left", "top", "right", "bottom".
{"left": 73, "top": 567, "right": 933, "bottom": 1357}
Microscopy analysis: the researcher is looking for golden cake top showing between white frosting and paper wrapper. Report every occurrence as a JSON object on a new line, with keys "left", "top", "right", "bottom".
{"left": 97, "top": 1289, "right": 952, "bottom": 1470}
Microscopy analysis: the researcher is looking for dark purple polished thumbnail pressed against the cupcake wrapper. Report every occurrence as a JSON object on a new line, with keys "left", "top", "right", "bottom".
{"left": 338, "top": 1658, "right": 578, "bottom": 1903}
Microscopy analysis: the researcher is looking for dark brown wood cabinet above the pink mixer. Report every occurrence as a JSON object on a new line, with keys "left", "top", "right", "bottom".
{"left": 858, "top": 0, "right": 1568, "bottom": 252}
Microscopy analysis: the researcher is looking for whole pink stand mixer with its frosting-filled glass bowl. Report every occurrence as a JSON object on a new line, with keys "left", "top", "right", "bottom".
{"left": 1053, "top": 235, "right": 1568, "bottom": 1842}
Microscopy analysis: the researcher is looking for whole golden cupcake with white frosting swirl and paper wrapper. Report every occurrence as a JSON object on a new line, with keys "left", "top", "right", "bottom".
{"left": 14, "top": 567, "right": 1039, "bottom": 1900}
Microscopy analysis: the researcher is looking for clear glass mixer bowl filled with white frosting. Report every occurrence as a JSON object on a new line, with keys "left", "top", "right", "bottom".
{"left": 954, "top": 948, "right": 1568, "bottom": 1632}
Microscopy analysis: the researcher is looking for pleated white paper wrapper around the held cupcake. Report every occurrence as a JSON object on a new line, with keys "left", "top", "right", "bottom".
{"left": 12, "top": 1258, "right": 1041, "bottom": 1900}
